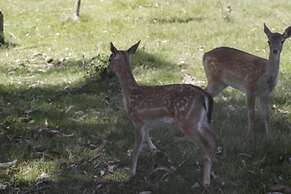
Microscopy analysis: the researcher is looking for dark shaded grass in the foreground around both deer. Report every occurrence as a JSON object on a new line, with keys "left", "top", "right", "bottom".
{"left": 0, "top": 51, "right": 291, "bottom": 194}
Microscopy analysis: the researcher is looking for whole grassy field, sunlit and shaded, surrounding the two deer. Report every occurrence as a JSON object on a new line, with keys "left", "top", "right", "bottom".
{"left": 0, "top": 0, "right": 291, "bottom": 194}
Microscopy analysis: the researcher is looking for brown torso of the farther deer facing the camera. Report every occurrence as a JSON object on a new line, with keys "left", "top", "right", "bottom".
{"left": 203, "top": 47, "right": 279, "bottom": 96}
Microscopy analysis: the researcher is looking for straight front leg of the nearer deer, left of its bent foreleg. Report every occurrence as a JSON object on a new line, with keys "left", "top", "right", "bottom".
{"left": 131, "top": 126, "right": 146, "bottom": 176}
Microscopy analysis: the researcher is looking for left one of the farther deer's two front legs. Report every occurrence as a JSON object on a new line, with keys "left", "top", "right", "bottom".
{"left": 247, "top": 94, "right": 256, "bottom": 136}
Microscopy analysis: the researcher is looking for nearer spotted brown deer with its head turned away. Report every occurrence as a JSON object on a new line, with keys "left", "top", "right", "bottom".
{"left": 109, "top": 41, "right": 216, "bottom": 186}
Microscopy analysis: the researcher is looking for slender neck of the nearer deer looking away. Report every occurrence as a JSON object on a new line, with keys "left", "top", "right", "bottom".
{"left": 117, "top": 66, "right": 137, "bottom": 97}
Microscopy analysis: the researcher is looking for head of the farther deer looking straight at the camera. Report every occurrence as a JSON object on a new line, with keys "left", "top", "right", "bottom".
{"left": 264, "top": 24, "right": 291, "bottom": 55}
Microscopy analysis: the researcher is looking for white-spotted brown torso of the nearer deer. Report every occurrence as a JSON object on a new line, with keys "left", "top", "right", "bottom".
{"left": 123, "top": 84, "right": 212, "bottom": 122}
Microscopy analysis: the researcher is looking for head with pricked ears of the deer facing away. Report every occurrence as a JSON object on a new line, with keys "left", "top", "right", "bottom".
{"left": 109, "top": 41, "right": 140, "bottom": 73}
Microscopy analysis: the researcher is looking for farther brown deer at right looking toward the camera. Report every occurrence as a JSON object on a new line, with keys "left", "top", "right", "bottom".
{"left": 203, "top": 24, "right": 291, "bottom": 135}
